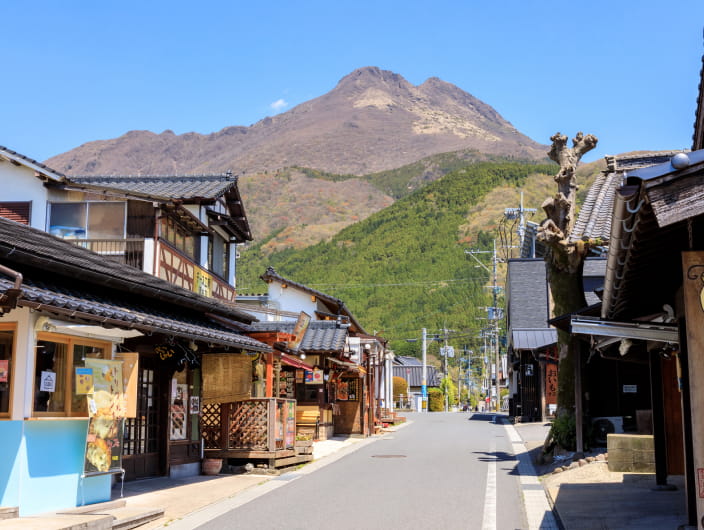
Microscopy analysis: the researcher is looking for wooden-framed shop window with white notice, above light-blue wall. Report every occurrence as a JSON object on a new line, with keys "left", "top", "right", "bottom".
{"left": 33, "top": 333, "right": 112, "bottom": 417}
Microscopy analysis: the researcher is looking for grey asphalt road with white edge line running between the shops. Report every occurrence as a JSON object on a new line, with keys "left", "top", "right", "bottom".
{"left": 199, "top": 413, "right": 527, "bottom": 530}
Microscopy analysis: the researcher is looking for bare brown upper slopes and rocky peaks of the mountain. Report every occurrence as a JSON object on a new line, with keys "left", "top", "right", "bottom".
{"left": 46, "top": 67, "right": 547, "bottom": 175}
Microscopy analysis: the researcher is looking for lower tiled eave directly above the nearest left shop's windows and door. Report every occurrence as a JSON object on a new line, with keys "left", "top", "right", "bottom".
{"left": 0, "top": 270, "right": 270, "bottom": 351}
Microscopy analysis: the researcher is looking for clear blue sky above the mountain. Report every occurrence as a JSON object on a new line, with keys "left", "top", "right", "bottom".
{"left": 0, "top": 0, "right": 704, "bottom": 165}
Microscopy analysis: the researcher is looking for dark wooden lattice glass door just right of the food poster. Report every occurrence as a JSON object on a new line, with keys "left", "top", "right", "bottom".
{"left": 122, "top": 355, "right": 163, "bottom": 480}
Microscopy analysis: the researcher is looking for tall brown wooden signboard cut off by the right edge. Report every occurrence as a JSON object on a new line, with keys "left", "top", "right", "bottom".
{"left": 682, "top": 252, "right": 704, "bottom": 518}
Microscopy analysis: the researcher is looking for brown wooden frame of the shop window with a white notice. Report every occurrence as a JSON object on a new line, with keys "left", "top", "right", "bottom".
{"left": 32, "top": 331, "right": 113, "bottom": 418}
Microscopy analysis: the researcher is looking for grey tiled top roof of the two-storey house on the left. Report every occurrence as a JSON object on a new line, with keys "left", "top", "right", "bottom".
{"left": 68, "top": 173, "right": 237, "bottom": 200}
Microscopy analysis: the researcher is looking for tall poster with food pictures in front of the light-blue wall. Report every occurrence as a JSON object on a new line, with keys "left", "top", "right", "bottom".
{"left": 84, "top": 359, "right": 126, "bottom": 475}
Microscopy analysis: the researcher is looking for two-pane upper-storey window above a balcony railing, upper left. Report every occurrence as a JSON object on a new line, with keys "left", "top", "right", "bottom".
{"left": 49, "top": 201, "right": 127, "bottom": 239}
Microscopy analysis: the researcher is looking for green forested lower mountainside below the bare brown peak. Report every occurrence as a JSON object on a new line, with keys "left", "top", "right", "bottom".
{"left": 237, "top": 160, "right": 568, "bottom": 351}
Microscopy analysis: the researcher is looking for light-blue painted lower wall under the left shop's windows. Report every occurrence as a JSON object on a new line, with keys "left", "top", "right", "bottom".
{"left": 0, "top": 420, "right": 111, "bottom": 516}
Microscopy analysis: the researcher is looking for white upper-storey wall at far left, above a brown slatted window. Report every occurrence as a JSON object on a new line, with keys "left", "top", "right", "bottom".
{"left": 0, "top": 159, "right": 48, "bottom": 230}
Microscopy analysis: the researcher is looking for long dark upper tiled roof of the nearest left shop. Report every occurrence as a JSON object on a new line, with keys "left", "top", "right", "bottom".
{"left": 0, "top": 217, "right": 256, "bottom": 323}
